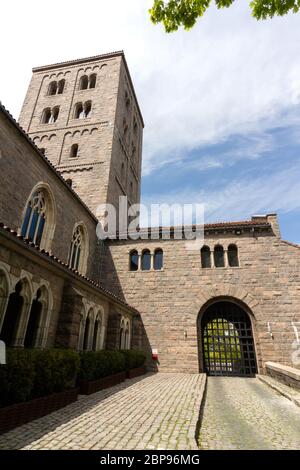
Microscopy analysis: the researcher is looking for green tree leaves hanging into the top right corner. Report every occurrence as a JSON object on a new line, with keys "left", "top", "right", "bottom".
{"left": 149, "top": 0, "right": 300, "bottom": 33}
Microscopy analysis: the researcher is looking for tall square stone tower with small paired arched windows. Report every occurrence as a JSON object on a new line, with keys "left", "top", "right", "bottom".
{"left": 19, "top": 51, "right": 144, "bottom": 218}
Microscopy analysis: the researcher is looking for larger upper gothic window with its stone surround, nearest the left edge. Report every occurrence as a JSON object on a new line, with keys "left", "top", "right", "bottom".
{"left": 21, "top": 185, "right": 55, "bottom": 250}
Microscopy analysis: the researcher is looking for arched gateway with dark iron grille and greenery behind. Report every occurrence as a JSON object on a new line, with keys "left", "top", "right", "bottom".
{"left": 201, "top": 301, "right": 257, "bottom": 377}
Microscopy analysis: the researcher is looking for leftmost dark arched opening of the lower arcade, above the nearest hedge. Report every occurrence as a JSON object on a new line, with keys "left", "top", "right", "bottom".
{"left": 0, "top": 281, "right": 25, "bottom": 347}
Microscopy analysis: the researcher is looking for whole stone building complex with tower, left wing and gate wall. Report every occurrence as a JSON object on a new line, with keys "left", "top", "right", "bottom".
{"left": 0, "top": 52, "right": 300, "bottom": 375}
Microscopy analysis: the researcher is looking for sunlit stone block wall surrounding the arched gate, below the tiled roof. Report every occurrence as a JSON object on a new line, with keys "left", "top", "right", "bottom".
{"left": 103, "top": 215, "right": 300, "bottom": 372}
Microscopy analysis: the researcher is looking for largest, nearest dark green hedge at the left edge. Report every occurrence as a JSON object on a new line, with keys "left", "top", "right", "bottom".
{"left": 0, "top": 349, "right": 80, "bottom": 407}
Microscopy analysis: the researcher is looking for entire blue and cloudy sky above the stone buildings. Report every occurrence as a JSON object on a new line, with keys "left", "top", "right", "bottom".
{"left": 0, "top": 0, "right": 300, "bottom": 243}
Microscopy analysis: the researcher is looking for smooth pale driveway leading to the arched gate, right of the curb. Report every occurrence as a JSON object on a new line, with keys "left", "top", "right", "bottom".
{"left": 199, "top": 377, "right": 300, "bottom": 450}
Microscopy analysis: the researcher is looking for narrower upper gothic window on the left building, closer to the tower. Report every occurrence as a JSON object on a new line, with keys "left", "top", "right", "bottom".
{"left": 69, "top": 224, "right": 88, "bottom": 273}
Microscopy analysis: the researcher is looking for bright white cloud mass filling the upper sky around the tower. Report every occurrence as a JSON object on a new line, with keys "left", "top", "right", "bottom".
{"left": 0, "top": 0, "right": 300, "bottom": 178}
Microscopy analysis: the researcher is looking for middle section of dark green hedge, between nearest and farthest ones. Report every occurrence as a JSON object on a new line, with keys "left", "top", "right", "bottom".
{"left": 78, "top": 350, "right": 125, "bottom": 381}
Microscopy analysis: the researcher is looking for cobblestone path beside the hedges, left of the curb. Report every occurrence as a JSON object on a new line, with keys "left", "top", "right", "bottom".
{"left": 0, "top": 373, "right": 205, "bottom": 449}
